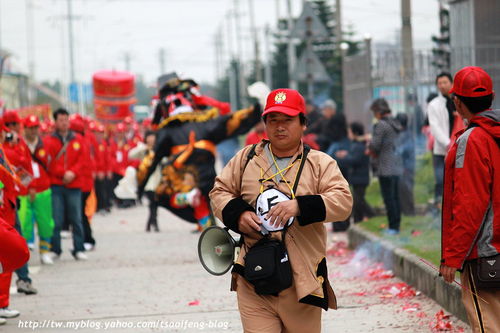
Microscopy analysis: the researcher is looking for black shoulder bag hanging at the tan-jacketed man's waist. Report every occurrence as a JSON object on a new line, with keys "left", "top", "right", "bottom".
{"left": 244, "top": 146, "right": 310, "bottom": 296}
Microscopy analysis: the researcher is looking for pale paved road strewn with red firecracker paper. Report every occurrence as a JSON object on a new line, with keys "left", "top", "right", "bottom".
{"left": 6, "top": 207, "right": 468, "bottom": 333}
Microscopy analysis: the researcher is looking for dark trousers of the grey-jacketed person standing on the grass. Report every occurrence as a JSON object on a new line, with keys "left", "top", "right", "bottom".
{"left": 378, "top": 176, "right": 401, "bottom": 231}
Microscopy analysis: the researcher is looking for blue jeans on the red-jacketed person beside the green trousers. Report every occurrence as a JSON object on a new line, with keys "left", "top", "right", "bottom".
{"left": 51, "top": 185, "right": 85, "bottom": 254}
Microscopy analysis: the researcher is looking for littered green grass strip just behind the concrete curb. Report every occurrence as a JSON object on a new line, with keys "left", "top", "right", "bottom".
{"left": 358, "top": 216, "right": 441, "bottom": 267}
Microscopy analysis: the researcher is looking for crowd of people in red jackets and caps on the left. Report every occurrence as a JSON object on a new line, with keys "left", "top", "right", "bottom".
{"left": 0, "top": 105, "right": 152, "bottom": 318}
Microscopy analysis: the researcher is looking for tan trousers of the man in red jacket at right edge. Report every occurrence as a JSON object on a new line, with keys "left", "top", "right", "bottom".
{"left": 460, "top": 263, "right": 500, "bottom": 333}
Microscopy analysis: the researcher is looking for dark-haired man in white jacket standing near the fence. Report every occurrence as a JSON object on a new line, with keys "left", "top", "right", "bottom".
{"left": 427, "top": 72, "right": 455, "bottom": 203}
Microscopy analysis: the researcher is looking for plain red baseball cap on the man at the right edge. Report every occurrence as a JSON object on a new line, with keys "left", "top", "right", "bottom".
{"left": 450, "top": 66, "right": 493, "bottom": 97}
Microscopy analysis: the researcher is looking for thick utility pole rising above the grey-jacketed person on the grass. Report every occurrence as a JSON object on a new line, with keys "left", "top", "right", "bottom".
{"left": 401, "top": 0, "right": 414, "bottom": 112}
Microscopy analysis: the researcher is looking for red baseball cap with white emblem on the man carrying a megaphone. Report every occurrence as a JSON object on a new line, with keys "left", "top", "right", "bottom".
{"left": 262, "top": 89, "right": 306, "bottom": 117}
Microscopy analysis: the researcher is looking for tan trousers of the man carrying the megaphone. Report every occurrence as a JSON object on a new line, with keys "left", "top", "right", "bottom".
{"left": 236, "top": 275, "right": 321, "bottom": 333}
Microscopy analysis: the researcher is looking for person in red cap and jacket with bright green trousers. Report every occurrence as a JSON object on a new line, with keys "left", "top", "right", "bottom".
{"left": 18, "top": 115, "right": 54, "bottom": 265}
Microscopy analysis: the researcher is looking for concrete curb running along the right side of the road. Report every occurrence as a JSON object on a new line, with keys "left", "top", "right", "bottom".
{"left": 347, "top": 225, "right": 468, "bottom": 322}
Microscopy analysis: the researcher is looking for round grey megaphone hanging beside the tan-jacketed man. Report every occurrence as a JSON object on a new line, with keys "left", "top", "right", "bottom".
{"left": 198, "top": 226, "right": 239, "bottom": 275}
